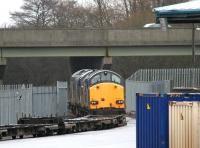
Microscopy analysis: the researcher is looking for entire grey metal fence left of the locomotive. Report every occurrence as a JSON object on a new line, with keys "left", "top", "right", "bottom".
{"left": 0, "top": 82, "right": 68, "bottom": 125}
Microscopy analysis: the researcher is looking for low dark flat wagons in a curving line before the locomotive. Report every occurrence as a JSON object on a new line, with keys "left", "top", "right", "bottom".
{"left": 0, "top": 115, "right": 127, "bottom": 139}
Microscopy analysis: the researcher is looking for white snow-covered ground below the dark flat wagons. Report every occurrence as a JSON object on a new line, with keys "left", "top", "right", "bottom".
{"left": 0, "top": 118, "right": 136, "bottom": 148}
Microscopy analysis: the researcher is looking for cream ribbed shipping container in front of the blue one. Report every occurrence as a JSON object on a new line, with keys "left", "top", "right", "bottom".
{"left": 169, "top": 102, "right": 200, "bottom": 148}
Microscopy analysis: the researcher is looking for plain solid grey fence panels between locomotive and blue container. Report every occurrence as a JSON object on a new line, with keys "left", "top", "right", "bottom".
{"left": 126, "top": 79, "right": 171, "bottom": 113}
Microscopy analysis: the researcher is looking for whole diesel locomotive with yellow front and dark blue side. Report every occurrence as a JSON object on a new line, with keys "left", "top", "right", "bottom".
{"left": 69, "top": 69, "right": 125, "bottom": 116}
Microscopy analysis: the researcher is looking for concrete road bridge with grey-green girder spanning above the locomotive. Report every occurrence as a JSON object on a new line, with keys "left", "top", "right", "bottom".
{"left": 0, "top": 29, "right": 200, "bottom": 80}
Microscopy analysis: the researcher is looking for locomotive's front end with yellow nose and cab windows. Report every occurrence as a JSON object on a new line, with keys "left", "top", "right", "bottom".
{"left": 88, "top": 70, "right": 125, "bottom": 113}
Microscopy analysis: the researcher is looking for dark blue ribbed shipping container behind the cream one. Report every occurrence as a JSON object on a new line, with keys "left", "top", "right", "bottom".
{"left": 136, "top": 94, "right": 200, "bottom": 148}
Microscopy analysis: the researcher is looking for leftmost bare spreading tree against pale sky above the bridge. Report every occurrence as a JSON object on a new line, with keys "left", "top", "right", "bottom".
{"left": 11, "top": 0, "right": 57, "bottom": 28}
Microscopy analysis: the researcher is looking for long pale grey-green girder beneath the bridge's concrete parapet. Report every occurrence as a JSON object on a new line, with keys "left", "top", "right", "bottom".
{"left": 0, "top": 45, "right": 200, "bottom": 58}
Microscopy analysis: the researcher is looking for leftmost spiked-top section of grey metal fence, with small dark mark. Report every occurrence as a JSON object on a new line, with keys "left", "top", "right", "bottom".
{"left": 0, "top": 85, "right": 32, "bottom": 125}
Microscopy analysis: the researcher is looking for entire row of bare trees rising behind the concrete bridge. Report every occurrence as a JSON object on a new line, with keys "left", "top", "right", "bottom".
{"left": 11, "top": 0, "right": 191, "bottom": 28}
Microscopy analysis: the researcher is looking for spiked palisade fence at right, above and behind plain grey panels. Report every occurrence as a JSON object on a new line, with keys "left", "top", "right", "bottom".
{"left": 128, "top": 68, "right": 200, "bottom": 87}
